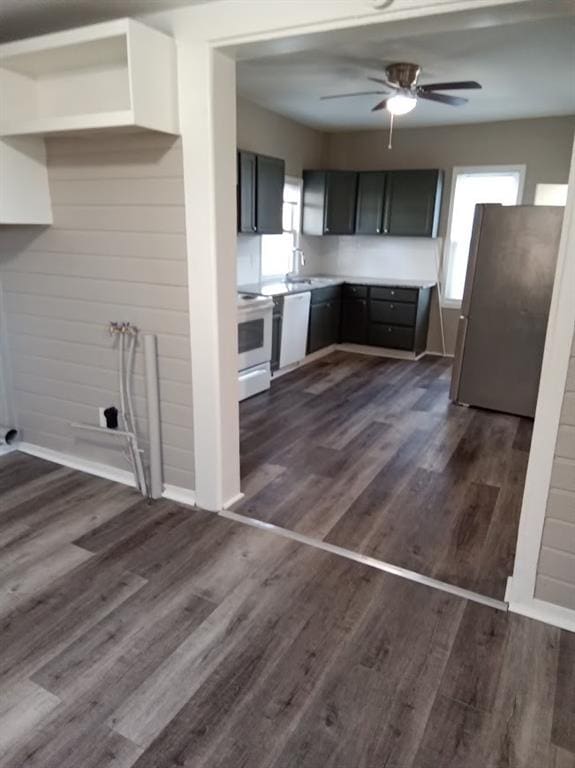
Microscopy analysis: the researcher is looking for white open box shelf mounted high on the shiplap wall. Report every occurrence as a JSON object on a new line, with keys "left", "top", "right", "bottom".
{"left": 0, "top": 19, "right": 178, "bottom": 137}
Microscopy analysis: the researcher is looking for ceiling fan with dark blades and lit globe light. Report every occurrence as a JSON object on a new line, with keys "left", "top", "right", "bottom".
{"left": 321, "top": 63, "right": 481, "bottom": 115}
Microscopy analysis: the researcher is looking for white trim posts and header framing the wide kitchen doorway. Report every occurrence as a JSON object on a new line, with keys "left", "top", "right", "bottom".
{"left": 162, "top": 0, "right": 575, "bottom": 625}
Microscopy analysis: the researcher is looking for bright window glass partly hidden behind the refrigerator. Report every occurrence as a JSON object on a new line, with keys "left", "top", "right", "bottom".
{"left": 445, "top": 171, "right": 520, "bottom": 301}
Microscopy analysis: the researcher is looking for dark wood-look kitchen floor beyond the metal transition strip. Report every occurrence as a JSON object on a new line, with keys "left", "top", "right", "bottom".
{"left": 235, "top": 351, "right": 531, "bottom": 599}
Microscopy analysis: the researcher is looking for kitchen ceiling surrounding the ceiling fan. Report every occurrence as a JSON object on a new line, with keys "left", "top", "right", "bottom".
{"left": 238, "top": 16, "right": 575, "bottom": 131}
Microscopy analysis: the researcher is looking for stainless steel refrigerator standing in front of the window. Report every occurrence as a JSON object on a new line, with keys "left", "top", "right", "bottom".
{"left": 451, "top": 204, "right": 564, "bottom": 417}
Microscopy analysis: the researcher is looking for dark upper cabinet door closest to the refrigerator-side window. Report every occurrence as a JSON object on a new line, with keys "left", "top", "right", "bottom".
{"left": 383, "top": 170, "right": 442, "bottom": 237}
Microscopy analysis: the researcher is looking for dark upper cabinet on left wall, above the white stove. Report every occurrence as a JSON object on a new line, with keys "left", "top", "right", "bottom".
{"left": 238, "top": 152, "right": 285, "bottom": 235}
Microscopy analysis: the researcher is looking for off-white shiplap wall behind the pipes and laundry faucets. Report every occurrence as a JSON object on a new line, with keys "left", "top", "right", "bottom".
{"left": 0, "top": 133, "right": 194, "bottom": 489}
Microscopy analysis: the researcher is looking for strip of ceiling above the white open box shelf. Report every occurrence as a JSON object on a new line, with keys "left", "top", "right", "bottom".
{"left": 0, "top": 0, "right": 215, "bottom": 43}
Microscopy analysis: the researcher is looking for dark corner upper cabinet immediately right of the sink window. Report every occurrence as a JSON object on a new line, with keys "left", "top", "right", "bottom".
{"left": 303, "top": 171, "right": 357, "bottom": 235}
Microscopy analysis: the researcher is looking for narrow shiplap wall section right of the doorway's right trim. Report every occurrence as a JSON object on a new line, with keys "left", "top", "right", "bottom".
{"left": 535, "top": 328, "right": 575, "bottom": 610}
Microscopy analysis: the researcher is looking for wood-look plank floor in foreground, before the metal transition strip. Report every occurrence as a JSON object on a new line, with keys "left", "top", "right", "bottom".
{"left": 0, "top": 454, "right": 575, "bottom": 768}
